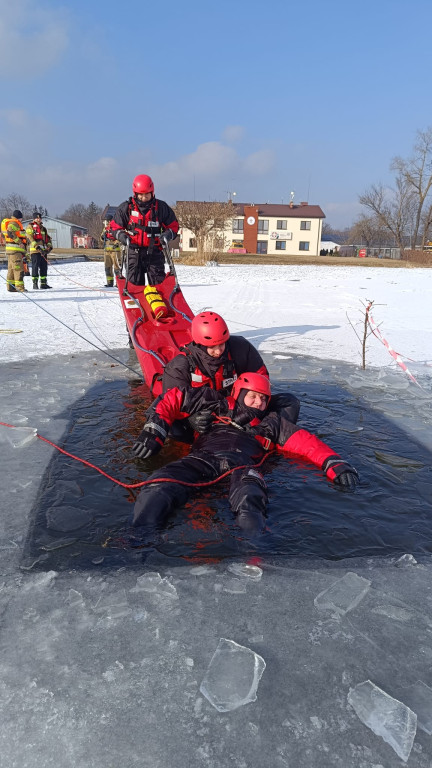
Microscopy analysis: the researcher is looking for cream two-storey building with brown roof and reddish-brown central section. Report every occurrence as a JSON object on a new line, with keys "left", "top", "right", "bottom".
{"left": 180, "top": 202, "right": 325, "bottom": 256}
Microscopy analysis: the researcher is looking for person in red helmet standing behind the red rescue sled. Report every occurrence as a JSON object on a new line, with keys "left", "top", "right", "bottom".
{"left": 110, "top": 174, "right": 179, "bottom": 285}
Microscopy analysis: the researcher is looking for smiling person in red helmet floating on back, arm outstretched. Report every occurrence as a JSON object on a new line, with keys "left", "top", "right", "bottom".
{"left": 132, "top": 373, "right": 358, "bottom": 535}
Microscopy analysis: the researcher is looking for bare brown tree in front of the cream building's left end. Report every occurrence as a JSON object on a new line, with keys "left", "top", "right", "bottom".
{"left": 175, "top": 200, "right": 237, "bottom": 261}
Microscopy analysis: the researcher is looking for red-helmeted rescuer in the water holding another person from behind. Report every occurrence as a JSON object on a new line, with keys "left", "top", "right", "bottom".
{"left": 157, "top": 311, "right": 300, "bottom": 442}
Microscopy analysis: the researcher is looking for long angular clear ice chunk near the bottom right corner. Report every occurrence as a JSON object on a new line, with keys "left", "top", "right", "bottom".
{"left": 348, "top": 680, "right": 417, "bottom": 763}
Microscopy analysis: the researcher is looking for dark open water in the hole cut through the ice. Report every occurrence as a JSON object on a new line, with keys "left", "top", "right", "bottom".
{"left": 22, "top": 355, "right": 432, "bottom": 570}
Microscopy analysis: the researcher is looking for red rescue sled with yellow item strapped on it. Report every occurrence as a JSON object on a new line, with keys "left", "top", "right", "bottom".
{"left": 117, "top": 246, "right": 194, "bottom": 397}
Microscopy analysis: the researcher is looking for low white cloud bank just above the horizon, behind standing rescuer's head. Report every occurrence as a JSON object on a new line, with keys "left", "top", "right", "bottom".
{"left": 0, "top": 134, "right": 273, "bottom": 214}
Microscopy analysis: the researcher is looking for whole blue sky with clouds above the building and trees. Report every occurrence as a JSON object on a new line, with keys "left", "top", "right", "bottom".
{"left": 0, "top": 0, "right": 432, "bottom": 226}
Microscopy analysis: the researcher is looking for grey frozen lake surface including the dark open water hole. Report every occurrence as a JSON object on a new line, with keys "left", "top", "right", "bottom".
{"left": 0, "top": 350, "right": 432, "bottom": 768}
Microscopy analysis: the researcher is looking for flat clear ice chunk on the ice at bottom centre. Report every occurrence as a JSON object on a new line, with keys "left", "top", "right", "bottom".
{"left": 200, "top": 637, "right": 266, "bottom": 712}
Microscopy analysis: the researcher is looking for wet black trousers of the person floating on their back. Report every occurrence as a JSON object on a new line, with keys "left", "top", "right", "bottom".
{"left": 132, "top": 454, "right": 268, "bottom": 535}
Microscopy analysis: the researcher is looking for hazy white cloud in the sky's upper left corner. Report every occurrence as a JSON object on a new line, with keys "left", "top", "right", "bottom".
{"left": 0, "top": 0, "right": 68, "bottom": 79}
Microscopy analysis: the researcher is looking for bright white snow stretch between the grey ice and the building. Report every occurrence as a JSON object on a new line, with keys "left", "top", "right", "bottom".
{"left": 0, "top": 262, "right": 432, "bottom": 367}
